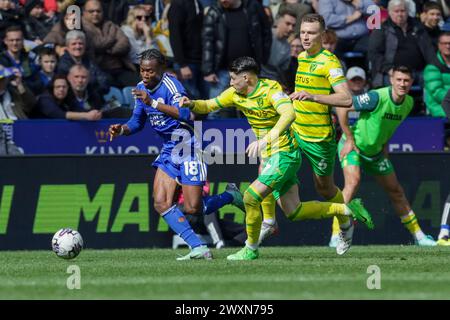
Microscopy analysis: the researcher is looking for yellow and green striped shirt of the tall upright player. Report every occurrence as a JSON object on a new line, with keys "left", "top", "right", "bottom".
{"left": 293, "top": 49, "right": 346, "bottom": 142}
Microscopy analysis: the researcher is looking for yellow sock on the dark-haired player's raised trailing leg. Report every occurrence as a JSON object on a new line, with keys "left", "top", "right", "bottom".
{"left": 288, "top": 201, "right": 347, "bottom": 221}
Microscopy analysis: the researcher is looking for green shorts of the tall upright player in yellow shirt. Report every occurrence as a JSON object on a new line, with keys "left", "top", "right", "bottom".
{"left": 295, "top": 132, "right": 337, "bottom": 177}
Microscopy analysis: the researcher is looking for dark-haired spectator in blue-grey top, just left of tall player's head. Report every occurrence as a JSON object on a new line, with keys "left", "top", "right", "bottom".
{"left": 261, "top": 9, "right": 297, "bottom": 83}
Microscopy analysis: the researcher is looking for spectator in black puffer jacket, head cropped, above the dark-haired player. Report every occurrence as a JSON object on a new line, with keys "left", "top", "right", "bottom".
{"left": 202, "top": 0, "right": 272, "bottom": 118}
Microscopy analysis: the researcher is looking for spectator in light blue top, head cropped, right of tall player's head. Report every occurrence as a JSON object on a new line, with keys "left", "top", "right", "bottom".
{"left": 319, "top": 0, "right": 375, "bottom": 58}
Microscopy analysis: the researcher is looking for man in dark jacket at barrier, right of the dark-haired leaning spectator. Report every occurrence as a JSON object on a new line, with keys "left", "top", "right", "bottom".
{"left": 67, "top": 64, "right": 105, "bottom": 112}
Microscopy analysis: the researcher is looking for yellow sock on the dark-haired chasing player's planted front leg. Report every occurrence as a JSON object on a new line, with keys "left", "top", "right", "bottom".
{"left": 244, "top": 186, "right": 263, "bottom": 249}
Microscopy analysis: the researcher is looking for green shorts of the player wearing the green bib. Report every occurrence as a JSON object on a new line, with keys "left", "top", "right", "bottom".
{"left": 338, "top": 138, "right": 394, "bottom": 176}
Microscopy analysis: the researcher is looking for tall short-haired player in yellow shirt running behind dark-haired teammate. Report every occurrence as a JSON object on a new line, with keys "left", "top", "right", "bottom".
{"left": 260, "top": 14, "right": 353, "bottom": 254}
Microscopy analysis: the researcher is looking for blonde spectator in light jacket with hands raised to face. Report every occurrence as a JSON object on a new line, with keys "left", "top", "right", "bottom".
{"left": 121, "top": 5, "right": 153, "bottom": 65}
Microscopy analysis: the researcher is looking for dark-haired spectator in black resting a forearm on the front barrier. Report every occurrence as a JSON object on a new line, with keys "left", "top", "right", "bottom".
{"left": 34, "top": 75, "right": 102, "bottom": 121}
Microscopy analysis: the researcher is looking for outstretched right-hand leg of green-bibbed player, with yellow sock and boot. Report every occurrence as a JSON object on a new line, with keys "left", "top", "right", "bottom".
{"left": 374, "top": 172, "right": 436, "bottom": 246}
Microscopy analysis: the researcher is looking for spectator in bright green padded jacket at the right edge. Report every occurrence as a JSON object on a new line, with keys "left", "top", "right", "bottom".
{"left": 423, "top": 32, "right": 450, "bottom": 117}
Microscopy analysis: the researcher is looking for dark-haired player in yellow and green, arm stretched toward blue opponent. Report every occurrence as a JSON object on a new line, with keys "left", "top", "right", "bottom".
{"left": 180, "top": 57, "right": 373, "bottom": 260}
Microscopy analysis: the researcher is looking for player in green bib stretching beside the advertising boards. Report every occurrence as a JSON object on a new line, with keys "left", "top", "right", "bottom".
{"left": 336, "top": 66, "right": 436, "bottom": 246}
